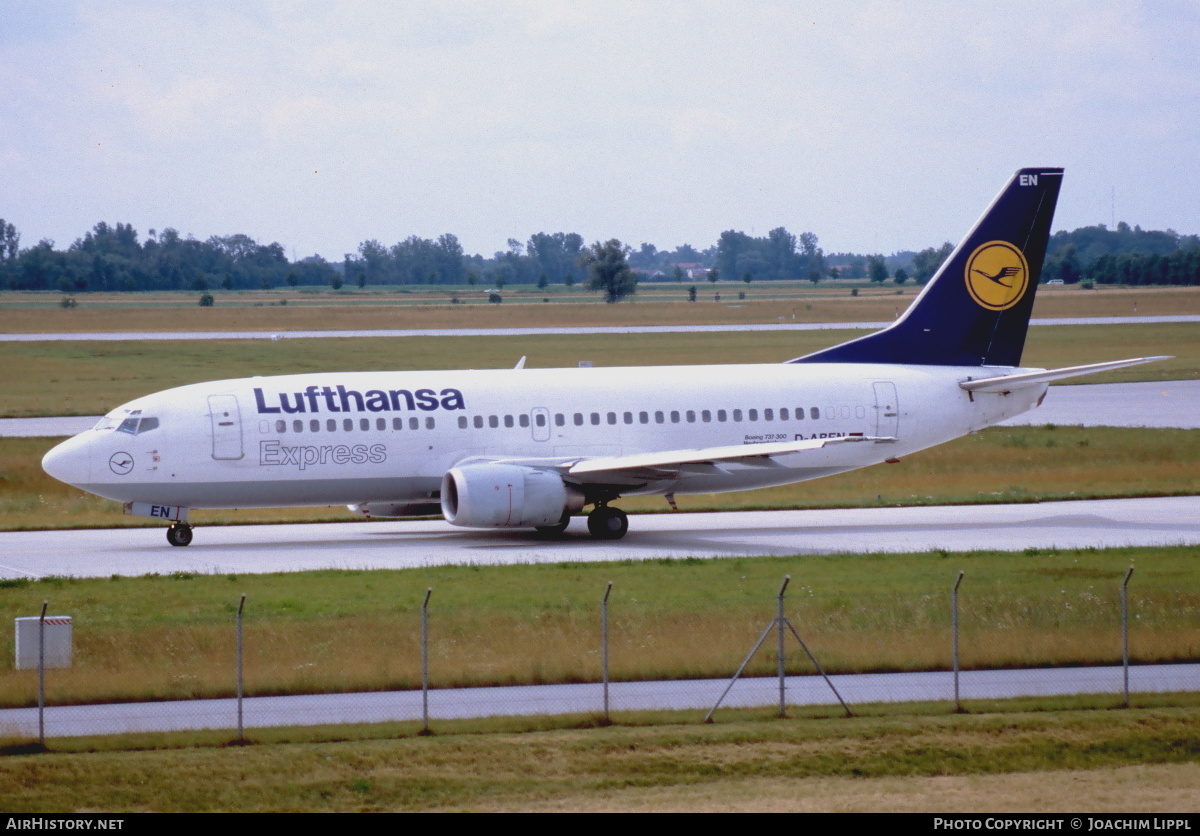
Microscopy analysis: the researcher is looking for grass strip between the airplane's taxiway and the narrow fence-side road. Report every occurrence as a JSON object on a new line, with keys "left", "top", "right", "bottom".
{"left": 0, "top": 547, "right": 1200, "bottom": 705}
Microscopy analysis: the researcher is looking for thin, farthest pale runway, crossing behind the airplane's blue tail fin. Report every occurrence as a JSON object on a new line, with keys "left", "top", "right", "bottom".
{"left": 9, "top": 314, "right": 1200, "bottom": 343}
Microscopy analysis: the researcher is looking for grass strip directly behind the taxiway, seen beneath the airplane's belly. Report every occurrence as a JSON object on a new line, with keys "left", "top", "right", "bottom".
{"left": 0, "top": 427, "right": 1200, "bottom": 530}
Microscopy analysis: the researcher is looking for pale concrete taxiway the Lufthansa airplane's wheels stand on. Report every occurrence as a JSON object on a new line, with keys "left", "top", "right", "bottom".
{"left": 0, "top": 497, "right": 1200, "bottom": 578}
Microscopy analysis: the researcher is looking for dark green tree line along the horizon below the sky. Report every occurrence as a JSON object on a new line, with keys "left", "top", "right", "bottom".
{"left": 0, "top": 218, "right": 1200, "bottom": 301}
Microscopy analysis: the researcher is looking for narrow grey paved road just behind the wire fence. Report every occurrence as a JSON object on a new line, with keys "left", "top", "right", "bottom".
{"left": 0, "top": 664, "right": 1200, "bottom": 739}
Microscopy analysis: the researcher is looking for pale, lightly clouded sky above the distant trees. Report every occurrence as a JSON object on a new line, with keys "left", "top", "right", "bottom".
{"left": 0, "top": 0, "right": 1200, "bottom": 260}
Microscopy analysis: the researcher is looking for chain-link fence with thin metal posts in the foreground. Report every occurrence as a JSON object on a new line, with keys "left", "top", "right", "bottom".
{"left": 0, "top": 569, "right": 1200, "bottom": 742}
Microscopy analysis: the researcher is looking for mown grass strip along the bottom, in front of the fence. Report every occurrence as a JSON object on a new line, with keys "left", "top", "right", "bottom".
{"left": 0, "top": 698, "right": 1200, "bottom": 810}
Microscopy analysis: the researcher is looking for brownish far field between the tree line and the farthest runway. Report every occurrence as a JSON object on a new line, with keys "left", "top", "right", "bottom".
{"left": 0, "top": 282, "right": 1200, "bottom": 333}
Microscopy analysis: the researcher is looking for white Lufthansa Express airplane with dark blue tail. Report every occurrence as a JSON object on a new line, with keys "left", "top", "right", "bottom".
{"left": 42, "top": 168, "right": 1162, "bottom": 546}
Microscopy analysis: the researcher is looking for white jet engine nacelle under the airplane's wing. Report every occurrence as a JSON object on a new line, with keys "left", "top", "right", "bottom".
{"left": 442, "top": 464, "right": 583, "bottom": 528}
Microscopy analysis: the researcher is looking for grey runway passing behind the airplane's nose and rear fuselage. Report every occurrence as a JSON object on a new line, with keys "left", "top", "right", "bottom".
{"left": 0, "top": 380, "right": 1200, "bottom": 438}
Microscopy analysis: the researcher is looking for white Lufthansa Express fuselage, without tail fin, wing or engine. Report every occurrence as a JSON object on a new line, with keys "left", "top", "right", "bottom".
{"left": 44, "top": 363, "right": 1045, "bottom": 509}
